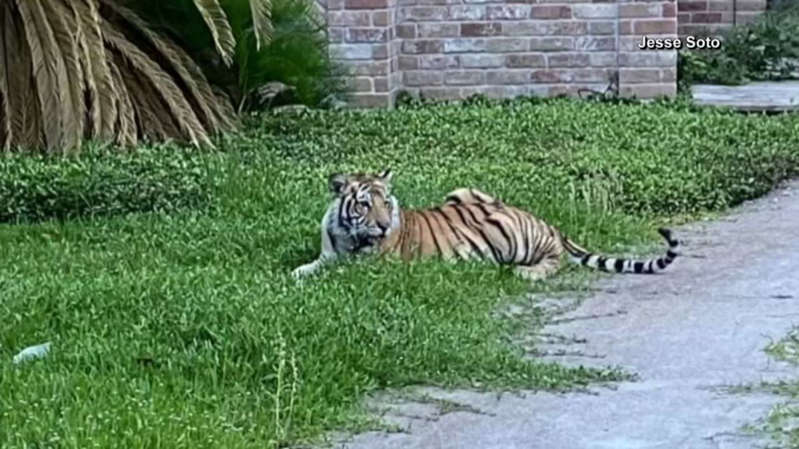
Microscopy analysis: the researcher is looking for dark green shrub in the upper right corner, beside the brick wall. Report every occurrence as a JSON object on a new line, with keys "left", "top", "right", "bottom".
{"left": 678, "top": 5, "right": 799, "bottom": 86}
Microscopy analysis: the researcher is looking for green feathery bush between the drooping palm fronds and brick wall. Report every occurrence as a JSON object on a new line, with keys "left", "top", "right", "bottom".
{"left": 131, "top": 0, "right": 344, "bottom": 110}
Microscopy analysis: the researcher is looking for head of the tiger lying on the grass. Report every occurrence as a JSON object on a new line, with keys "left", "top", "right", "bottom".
{"left": 329, "top": 170, "right": 400, "bottom": 244}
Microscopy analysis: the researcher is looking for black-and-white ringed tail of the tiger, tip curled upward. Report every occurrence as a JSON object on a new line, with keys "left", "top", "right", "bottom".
{"left": 561, "top": 228, "right": 680, "bottom": 274}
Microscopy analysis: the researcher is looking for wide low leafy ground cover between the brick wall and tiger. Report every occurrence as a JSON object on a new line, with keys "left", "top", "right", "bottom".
{"left": 253, "top": 99, "right": 799, "bottom": 215}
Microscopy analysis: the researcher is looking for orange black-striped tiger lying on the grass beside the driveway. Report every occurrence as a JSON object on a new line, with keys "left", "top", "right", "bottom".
{"left": 292, "top": 169, "right": 680, "bottom": 281}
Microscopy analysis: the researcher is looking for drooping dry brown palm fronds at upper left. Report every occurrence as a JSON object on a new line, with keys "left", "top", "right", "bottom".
{"left": 0, "top": 0, "right": 271, "bottom": 152}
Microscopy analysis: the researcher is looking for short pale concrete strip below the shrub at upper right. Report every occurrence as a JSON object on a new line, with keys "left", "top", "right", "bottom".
{"left": 691, "top": 81, "right": 799, "bottom": 112}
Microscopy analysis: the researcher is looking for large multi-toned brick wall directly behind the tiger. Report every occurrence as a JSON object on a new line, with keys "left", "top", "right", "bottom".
{"left": 325, "top": 0, "right": 680, "bottom": 106}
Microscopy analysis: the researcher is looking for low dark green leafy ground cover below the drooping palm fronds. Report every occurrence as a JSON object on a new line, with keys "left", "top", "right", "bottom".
{"left": 0, "top": 144, "right": 217, "bottom": 222}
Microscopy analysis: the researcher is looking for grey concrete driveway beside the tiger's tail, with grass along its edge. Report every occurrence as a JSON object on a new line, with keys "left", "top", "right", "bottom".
{"left": 336, "top": 182, "right": 799, "bottom": 449}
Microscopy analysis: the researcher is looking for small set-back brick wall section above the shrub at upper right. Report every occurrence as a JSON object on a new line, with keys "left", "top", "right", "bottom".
{"left": 677, "top": 0, "right": 766, "bottom": 37}
